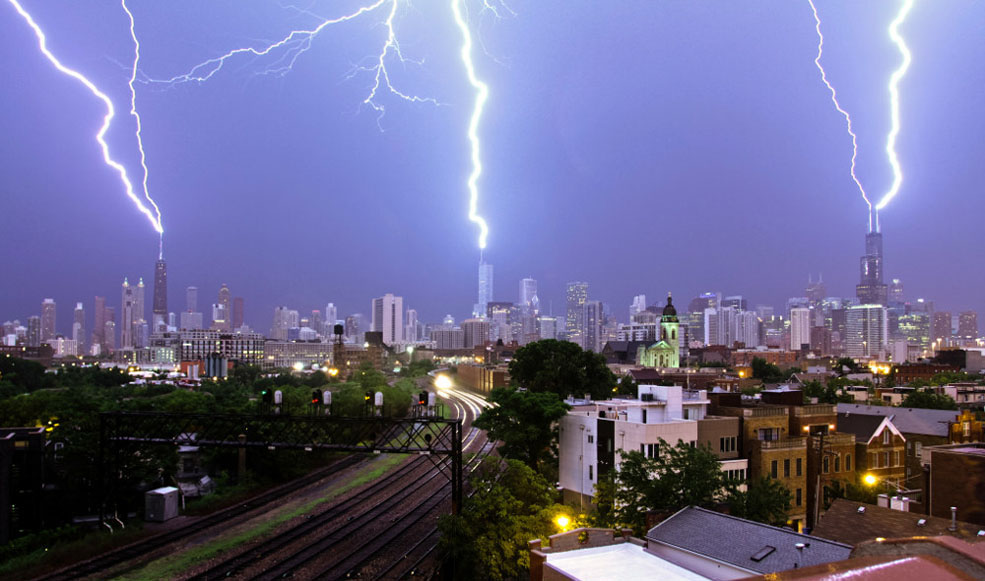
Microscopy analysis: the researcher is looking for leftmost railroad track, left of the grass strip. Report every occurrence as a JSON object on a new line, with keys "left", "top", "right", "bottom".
{"left": 34, "top": 455, "right": 364, "bottom": 581}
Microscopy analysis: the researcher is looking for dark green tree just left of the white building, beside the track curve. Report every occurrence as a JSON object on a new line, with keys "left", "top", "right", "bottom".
{"left": 473, "top": 387, "right": 570, "bottom": 470}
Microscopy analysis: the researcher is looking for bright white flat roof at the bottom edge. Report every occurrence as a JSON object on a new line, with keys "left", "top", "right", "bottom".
{"left": 545, "top": 543, "right": 708, "bottom": 581}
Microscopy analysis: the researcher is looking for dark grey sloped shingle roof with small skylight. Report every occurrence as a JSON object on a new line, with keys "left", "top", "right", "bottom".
{"left": 646, "top": 506, "right": 852, "bottom": 573}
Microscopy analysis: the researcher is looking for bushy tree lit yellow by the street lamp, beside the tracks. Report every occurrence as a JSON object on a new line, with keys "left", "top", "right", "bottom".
{"left": 438, "top": 458, "right": 565, "bottom": 580}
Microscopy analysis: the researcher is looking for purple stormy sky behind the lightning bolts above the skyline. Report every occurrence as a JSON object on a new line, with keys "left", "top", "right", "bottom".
{"left": 0, "top": 0, "right": 985, "bottom": 333}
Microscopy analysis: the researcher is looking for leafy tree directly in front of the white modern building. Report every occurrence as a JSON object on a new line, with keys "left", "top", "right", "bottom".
{"left": 615, "top": 440, "right": 728, "bottom": 534}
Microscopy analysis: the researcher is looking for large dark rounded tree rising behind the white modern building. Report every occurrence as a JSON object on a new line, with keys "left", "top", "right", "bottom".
{"left": 510, "top": 339, "right": 616, "bottom": 399}
